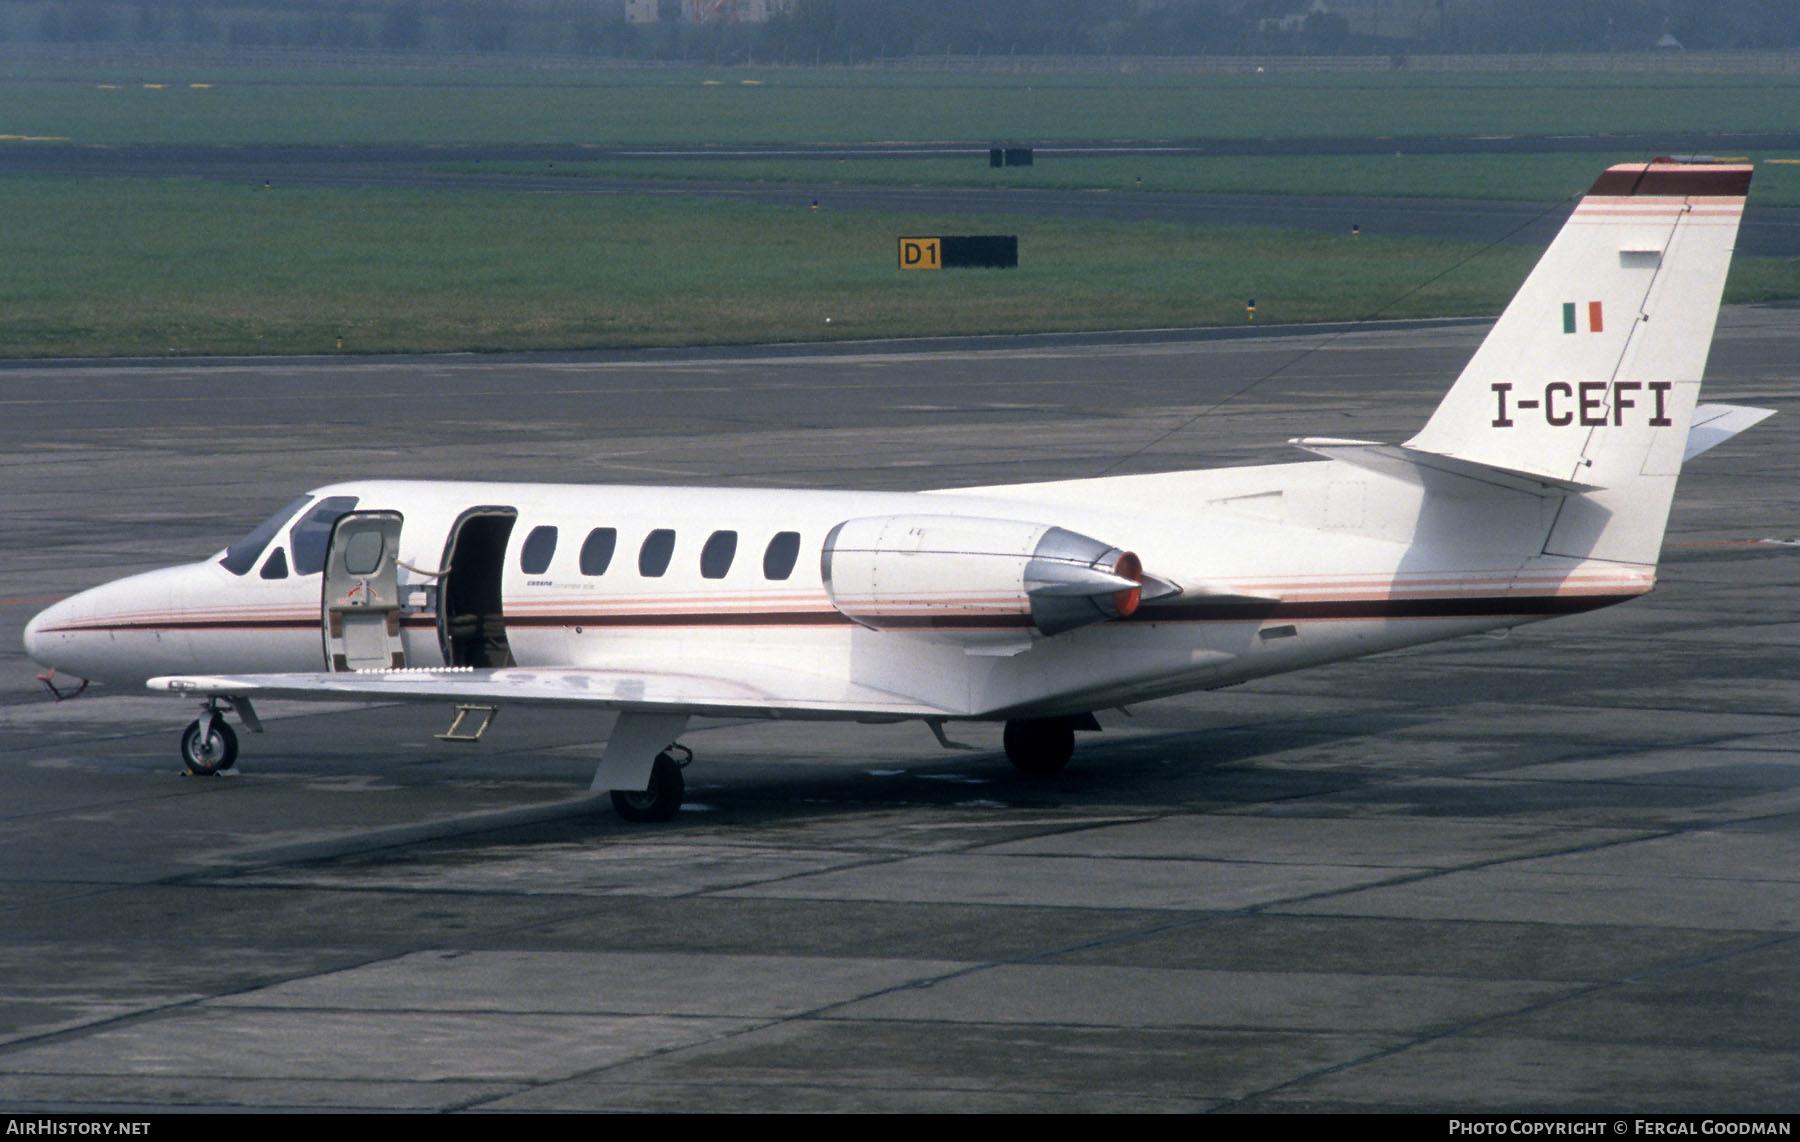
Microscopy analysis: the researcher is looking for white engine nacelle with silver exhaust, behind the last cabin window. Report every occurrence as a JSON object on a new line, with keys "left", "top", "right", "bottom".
{"left": 821, "top": 515, "right": 1143, "bottom": 634}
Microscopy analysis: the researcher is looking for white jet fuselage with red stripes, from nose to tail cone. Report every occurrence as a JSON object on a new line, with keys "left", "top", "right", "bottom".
{"left": 25, "top": 461, "right": 1652, "bottom": 717}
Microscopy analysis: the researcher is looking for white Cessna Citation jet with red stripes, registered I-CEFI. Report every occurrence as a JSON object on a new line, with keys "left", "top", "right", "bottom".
{"left": 25, "top": 160, "right": 1768, "bottom": 820}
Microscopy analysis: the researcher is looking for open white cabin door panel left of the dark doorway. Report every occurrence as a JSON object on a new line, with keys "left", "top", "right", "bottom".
{"left": 324, "top": 512, "right": 407, "bottom": 672}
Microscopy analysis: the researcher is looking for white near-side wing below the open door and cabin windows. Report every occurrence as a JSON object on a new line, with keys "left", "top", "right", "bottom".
{"left": 146, "top": 661, "right": 965, "bottom": 717}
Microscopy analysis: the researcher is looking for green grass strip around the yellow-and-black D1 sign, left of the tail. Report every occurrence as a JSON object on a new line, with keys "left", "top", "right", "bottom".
{"left": 0, "top": 180, "right": 1562, "bottom": 357}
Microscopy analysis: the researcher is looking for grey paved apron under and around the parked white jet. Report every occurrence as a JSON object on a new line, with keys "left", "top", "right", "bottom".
{"left": 0, "top": 308, "right": 1800, "bottom": 1111}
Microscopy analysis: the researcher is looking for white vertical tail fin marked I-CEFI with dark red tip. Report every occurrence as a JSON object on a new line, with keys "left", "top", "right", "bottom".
{"left": 1406, "top": 159, "right": 1750, "bottom": 564}
